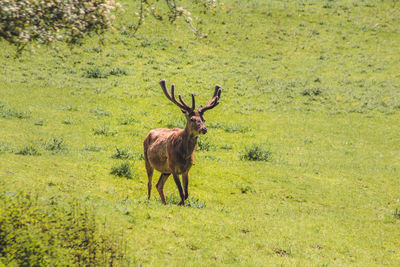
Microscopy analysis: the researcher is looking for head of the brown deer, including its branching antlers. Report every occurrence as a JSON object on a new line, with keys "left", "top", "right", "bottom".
{"left": 160, "top": 80, "right": 221, "bottom": 135}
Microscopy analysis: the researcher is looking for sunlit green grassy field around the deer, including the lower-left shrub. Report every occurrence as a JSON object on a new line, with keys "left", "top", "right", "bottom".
{"left": 0, "top": 0, "right": 400, "bottom": 266}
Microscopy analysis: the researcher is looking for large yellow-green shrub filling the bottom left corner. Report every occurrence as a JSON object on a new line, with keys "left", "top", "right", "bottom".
{"left": 0, "top": 192, "right": 125, "bottom": 266}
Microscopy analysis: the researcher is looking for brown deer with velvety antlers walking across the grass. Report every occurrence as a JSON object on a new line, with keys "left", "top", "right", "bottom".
{"left": 143, "top": 80, "right": 221, "bottom": 205}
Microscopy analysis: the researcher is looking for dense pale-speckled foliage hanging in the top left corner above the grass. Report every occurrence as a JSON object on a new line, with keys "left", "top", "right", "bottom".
{"left": 0, "top": 0, "right": 118, "bottom": 52}
